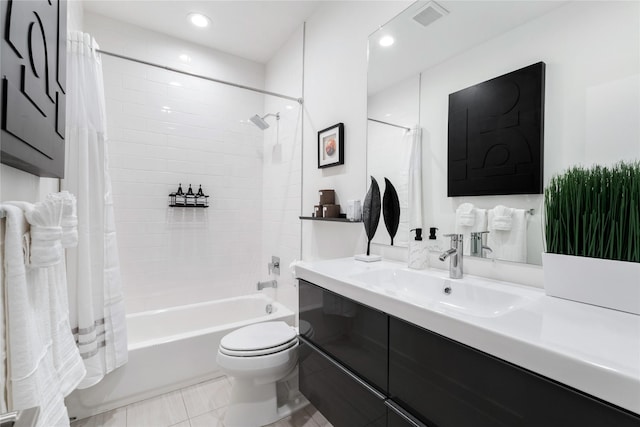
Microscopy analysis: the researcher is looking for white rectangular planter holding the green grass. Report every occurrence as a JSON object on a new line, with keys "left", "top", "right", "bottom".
{"left": 542, "top": 253, "right": 640, "bottom": 315}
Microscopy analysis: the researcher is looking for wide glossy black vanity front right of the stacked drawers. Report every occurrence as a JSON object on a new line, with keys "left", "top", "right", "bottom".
{"left": 389, "top": 317, "right": 640, "bottom": 427}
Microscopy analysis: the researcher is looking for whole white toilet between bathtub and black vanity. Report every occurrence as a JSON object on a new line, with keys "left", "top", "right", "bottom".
{"left": 216, "top": 321, "right": 308, "bottom": 427}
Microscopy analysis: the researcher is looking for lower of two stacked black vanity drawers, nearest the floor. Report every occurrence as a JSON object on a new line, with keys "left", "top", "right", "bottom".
{"left": 299, "top": 338, "right": 387, "bottom": 427}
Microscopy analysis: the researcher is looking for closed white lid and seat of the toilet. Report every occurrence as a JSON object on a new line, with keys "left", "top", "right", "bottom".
{"left": 220, "top": 321, "right": 296, "bottom": 352}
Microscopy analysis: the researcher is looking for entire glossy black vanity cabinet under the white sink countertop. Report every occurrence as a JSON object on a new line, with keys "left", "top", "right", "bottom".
{"left": 299, "top": 280, "right": 640, "bottom": 427}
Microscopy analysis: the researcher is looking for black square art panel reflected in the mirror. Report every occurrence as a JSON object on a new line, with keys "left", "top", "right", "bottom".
{"left": 447, "top": 62, "right": 545, "bottom": 197}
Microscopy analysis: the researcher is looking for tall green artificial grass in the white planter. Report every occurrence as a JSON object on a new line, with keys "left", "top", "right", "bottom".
{"left": 544, "top": 161, "right": 640, "bottom": 262}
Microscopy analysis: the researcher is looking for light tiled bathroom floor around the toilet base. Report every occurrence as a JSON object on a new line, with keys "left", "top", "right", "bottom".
{"left": 71, "top": 377, "right": 332, "bottom": 427}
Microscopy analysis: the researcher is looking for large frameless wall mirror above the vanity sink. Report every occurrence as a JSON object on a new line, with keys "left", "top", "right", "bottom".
{"left": 367, "top": 0, "right": 640, "bottom": 265}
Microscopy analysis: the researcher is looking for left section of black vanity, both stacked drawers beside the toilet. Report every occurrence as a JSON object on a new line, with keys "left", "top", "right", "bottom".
{"left": 299, "top": 280, "right": 423, "bottom": 427}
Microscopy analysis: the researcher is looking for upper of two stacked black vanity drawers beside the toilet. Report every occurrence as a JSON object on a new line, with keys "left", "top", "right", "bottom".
{"left": 299, "top": 280, "right": 389, "bottom": 392}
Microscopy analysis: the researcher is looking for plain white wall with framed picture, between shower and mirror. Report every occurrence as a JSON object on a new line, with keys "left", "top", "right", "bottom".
{"left": 302, "top": 1, "right": 409, "bottom": 260}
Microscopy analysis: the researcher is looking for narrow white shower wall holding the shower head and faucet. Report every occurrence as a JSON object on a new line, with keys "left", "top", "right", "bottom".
{"left": 258, "top": 26, "right": 304, "bottom": 311}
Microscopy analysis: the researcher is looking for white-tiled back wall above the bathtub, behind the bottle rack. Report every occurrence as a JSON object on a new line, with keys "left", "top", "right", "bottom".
{"left": 85, "top": 13, "right": 266, "bottom": 313}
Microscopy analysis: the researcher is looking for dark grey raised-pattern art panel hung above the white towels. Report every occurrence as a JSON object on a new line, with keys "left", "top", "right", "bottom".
{"left": 0, "top": 0, "right": 67, "bottom": 178}
